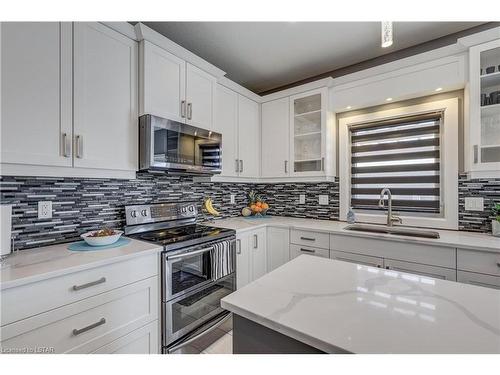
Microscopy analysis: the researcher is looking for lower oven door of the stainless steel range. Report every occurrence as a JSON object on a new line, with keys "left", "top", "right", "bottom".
{"left": 171, "top": 276, "right": 234, "bottom": 334}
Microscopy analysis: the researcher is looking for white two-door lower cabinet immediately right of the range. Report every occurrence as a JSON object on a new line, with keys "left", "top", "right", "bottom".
{"left": 236, "top": 228, "right": 267, "bottom": 289}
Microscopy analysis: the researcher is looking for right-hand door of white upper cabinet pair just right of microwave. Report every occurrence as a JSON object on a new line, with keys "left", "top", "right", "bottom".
{"left": 238, "top": 95, "right": 260, "bottom": 177}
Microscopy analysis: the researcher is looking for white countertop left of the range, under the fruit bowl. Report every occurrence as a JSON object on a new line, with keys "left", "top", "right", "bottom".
{"left": 0, "top": 239, "right": 162, "bottom": 289}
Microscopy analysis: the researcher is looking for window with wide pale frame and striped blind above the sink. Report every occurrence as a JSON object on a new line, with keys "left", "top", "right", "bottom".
{"left": 338, "top": 98, "right": 459, "bottom": 229}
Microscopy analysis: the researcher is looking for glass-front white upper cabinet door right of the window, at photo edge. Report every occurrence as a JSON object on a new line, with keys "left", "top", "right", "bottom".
{"left": 470, "top": 40, "right": 500, "bottom": 172}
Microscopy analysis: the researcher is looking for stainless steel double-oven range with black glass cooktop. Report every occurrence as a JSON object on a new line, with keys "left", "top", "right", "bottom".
{"left": 125, "top": 203, "right": 236, "bottom": 353}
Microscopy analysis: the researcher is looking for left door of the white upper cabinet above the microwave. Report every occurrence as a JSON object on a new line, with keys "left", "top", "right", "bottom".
{"left": 139, "top": 40, "right": 186, "bottom": 122}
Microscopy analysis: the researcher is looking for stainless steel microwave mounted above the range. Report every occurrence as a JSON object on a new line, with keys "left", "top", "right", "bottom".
{"left": 139, "top": 115, "right": 222, "bottom": 174}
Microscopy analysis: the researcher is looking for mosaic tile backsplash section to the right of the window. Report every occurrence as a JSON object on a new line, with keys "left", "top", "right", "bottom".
{"left": 458, "top": 175, "right": 500, "bottom": 233}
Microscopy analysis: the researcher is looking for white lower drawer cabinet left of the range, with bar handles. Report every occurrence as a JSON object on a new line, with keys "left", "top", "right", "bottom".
{"left": 0, "top": 254, "right": 160, "bottom": 353}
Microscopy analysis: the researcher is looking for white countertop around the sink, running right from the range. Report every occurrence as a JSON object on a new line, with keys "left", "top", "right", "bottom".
{"left": 206, "top": 216, "right": 500, "bottom": 252}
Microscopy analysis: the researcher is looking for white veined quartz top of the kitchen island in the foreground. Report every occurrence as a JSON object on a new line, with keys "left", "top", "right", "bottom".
{"left": 222, "top": 255, "right": 500, "bottom": 353}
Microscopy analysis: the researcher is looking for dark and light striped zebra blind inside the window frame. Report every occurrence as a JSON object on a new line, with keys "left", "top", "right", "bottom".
{"left": 350, "top": 112, "right": 443, "bottom": 214}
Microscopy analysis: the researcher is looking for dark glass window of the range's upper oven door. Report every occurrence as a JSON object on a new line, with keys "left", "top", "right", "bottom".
{"left": 170, "top": 251, "right": 211, "bottom": 295}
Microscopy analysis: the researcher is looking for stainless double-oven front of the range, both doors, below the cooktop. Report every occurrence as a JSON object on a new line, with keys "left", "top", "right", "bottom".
{"left": 162, "top": 237, "right": 236, "bottom": 346}
